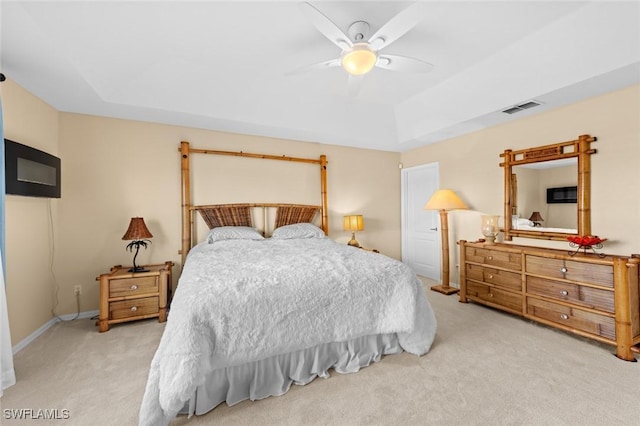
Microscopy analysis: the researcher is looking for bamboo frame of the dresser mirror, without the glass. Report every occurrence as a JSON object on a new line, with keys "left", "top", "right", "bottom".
{"left": 500, "top": 135, "right": 597, "bottom": 241}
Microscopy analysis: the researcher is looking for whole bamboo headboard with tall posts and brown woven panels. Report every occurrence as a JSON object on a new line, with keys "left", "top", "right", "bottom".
{"left": 180, "top": 141, "right": 329, "bottom": 265}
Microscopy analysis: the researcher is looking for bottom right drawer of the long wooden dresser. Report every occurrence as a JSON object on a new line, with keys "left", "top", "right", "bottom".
{"left": 527, "top": 297, "right": 616, "bottom": 340}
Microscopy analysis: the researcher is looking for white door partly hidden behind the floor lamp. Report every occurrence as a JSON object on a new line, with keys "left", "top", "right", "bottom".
{"left": 401, "top": 163, "right": 441, "bottom": 281}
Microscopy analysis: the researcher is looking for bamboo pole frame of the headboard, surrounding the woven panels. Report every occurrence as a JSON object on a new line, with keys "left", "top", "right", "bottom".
{"left": 179, "top": 141, "right": 329, "bottom": 265}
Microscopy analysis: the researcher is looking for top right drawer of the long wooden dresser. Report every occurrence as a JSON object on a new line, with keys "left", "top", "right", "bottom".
{"left": 525, "top": 255, "right": 613, "bottom": 288}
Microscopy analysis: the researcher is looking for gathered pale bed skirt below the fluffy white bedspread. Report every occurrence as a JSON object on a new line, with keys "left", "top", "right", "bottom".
{"left": 181, "top": 333, "right": 402, "bottom": 416}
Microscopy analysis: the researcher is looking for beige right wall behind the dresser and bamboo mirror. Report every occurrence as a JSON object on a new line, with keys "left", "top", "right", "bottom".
{"left": 401, "top": 85, "right": 640, "bottom": 282}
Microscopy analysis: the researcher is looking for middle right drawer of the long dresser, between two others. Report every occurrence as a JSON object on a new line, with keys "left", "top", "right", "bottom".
{"left": 527, "top": 276, "right": 615, "bottom": 313}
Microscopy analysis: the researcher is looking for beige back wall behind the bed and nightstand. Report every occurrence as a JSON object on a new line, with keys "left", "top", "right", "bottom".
{"left": 58, "top": 113, "right": 400, "bottom": 324}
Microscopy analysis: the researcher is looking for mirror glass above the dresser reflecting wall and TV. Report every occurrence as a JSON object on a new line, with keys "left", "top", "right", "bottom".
{"left": 512, "top": 158, "right": 578, "bottom": 234}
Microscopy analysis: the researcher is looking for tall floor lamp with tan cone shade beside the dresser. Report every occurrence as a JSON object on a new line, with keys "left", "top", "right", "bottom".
{"left": 424, "top": 189, "right": 467, "bottom": 295}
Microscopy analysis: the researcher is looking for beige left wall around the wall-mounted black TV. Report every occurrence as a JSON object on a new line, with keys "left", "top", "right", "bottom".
{"left": 0, "top": 79, "right": 59, "bottom": 345}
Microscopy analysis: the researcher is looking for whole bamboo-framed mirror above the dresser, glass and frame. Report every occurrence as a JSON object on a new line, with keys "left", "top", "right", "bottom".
{"left": 500, "top": 135, "right": 596, "bottom": 241}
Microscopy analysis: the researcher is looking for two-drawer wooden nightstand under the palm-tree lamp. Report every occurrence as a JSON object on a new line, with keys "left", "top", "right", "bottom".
{"left": 96, "top": 262, "right": 173, "bottom": 333}
